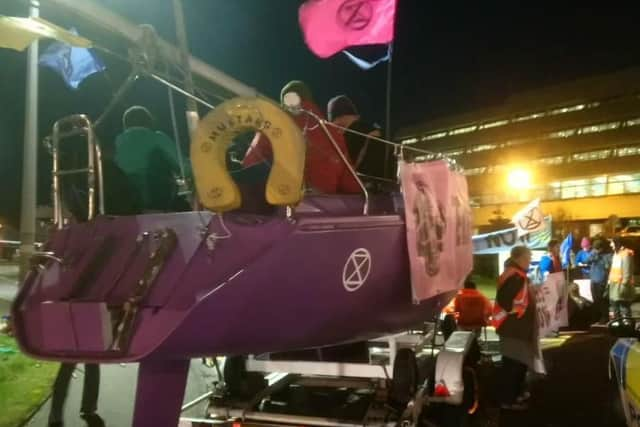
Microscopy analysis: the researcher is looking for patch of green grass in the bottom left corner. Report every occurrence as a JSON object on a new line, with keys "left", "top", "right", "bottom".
{"left": 0, "top": 335, "right": 58, "bottom": 427}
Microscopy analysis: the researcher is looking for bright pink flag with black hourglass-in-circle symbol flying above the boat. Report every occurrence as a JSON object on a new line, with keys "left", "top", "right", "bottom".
{"left": 298, "top": 0, "right": 396, "bottom": 58}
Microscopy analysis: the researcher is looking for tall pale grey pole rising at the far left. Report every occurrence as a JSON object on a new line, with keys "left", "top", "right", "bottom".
{"left": 20, "top": 0, "right": 40, "bottom": 280}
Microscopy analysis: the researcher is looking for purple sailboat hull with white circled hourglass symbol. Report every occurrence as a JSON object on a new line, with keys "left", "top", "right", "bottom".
{"left": 13, "top": 98, "right": 468, "bottom": 426}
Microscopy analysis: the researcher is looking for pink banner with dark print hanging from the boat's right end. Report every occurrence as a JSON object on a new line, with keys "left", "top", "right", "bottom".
{"left": 400, "top": 161, "right": 473, "bottom": 302}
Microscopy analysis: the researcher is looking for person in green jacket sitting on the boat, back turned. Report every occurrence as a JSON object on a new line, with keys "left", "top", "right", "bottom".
{"left": 115, "top": 105, "right": 188, "bottom": 212}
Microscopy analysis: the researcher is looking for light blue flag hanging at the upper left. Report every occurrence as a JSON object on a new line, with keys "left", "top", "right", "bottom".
{"left": 38, "top": 28, "right": 106, "bottom": 89}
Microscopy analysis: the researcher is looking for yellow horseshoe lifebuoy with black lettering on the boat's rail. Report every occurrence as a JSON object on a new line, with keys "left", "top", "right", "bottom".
{"left": 191, "top": 97, "right": 305, "bottom": 212}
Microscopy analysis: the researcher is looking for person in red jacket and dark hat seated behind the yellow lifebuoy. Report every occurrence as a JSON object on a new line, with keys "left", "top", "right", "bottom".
{"left": 242, "top": 80, "right": 361, "bottom": 194}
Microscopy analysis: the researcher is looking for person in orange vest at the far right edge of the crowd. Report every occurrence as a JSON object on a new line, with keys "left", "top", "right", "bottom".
{"left": 608, "top": 237, "right": 635, "bottom": 319}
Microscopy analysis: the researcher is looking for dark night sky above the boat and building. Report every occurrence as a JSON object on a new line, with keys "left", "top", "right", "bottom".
{"left": 0, "top": 0, "right": 640, "bottom": 225}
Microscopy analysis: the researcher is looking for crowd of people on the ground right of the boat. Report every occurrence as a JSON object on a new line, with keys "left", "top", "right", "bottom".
{"left": 443, "top": 237, "right": 635, "bottom": 410}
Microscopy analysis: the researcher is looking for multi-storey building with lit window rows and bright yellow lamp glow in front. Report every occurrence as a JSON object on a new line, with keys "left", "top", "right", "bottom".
{"left": 397, "top": 68, "right": 640, "bottom": 234}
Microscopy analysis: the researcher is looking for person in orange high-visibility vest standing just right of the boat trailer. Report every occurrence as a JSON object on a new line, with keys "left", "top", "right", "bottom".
{"left": 492, "top": 246, "right": 538, "bottom": 410}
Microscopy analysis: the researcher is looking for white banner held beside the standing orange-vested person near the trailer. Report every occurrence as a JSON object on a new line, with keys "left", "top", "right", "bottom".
{"left": 535, "top": 272, "right": 569, "bottom": 338}
